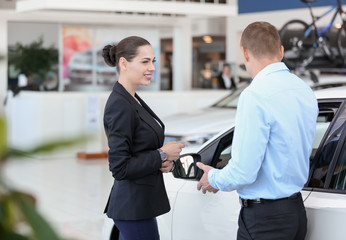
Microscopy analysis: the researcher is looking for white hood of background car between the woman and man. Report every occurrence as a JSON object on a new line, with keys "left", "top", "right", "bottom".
{"left": 163, "top": 107, "right": 236, "bottom": 136}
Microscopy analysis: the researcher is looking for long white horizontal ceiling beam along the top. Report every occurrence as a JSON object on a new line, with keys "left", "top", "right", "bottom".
{"left": 16, "top": 0, "right": 238, "bottom": 17}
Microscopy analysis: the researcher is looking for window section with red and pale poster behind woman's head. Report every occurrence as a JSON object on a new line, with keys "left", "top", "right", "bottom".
{"left": 61, "top": 26, "right": 160, "bottom": 91}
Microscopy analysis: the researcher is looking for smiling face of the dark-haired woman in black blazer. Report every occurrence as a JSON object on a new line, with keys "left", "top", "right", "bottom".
{"left": 126, "top": 45, "right": 155, "bottom": 86}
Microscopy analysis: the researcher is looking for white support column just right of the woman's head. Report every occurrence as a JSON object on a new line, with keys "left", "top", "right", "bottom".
{"left": 172, "top": 18, "right": 192, "bottom": 91}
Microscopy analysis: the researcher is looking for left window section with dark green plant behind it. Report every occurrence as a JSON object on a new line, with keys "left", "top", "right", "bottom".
{"left": 7, "top": 22, "right": 59, "bottom": 92}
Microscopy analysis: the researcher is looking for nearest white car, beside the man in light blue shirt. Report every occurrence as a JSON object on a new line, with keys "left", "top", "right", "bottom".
{"left": 104, "top": 87, "right": 346, "bottom": 240}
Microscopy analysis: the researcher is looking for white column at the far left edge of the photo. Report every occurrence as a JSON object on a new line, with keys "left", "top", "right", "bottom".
{"left": 0, "top": 10, "right": 8, "bottom": 106}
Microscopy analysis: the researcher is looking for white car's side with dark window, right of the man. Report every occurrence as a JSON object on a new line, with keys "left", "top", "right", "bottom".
{"left": 304, "top": 100, "right": 346, "bottom": 240}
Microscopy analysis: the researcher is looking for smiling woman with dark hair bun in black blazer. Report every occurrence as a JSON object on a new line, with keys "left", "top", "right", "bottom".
{"left": 103, "top": 36, "right": 184, "bottom": 240}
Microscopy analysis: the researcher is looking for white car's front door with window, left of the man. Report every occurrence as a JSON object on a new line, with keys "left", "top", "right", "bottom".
{"left": 172, "top": 128, "right": 240, "bottom": 240}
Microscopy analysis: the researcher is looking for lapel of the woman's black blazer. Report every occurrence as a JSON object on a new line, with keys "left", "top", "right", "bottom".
{"left": 113, "top": 82, "right": 164, "bottom": 147}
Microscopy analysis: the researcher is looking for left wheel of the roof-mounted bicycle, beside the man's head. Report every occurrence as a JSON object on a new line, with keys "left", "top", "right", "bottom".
{"left": 279, "top": 20, "right": 318, "bottom": 69}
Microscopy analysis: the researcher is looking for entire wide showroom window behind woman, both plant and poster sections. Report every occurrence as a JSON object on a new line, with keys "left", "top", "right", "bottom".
{"left": 8, "top": 22, "right": 161, "bottom": 94}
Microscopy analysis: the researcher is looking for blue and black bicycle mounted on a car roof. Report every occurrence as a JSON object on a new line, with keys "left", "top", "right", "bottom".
{"left": 280, "top": 0, "right": 346, "bottom": 69}
